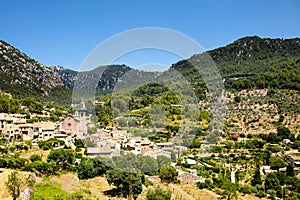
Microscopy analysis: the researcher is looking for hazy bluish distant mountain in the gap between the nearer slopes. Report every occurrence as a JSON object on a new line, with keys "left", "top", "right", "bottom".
{"left": 67, "top": 65, "right": 160, "bottom": 98}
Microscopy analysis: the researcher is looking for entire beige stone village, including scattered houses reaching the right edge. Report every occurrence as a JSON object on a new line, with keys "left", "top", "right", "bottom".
{"left": 0, "top": 97, "right": 300, "bottom": 195}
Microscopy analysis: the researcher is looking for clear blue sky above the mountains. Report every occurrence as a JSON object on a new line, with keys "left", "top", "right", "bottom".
{"left": 0, "top": 0, "right": 300, "bottom": 69}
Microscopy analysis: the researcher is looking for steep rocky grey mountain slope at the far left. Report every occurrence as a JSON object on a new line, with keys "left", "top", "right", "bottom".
{"left": 0, "top": 40, "right": 68, "bottom": 104}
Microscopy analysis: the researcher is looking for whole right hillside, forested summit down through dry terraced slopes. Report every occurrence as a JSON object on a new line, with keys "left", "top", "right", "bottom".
{"left": 109, "top": 37, "right": 300, "bottom": 139}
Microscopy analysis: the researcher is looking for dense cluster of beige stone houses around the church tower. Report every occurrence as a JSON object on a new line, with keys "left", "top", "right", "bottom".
{"left": 0, "top": 101, "right": 204, "bottom": 180}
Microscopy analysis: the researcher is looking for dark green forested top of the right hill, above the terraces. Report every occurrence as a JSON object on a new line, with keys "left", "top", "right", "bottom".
{"left": 171, "top": 36, "right": 300, "bottom": 90}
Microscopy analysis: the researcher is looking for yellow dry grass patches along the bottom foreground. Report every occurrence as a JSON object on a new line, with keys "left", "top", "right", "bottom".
{"left": 0, "top": 169, "right": 270, "bottom": 200}
